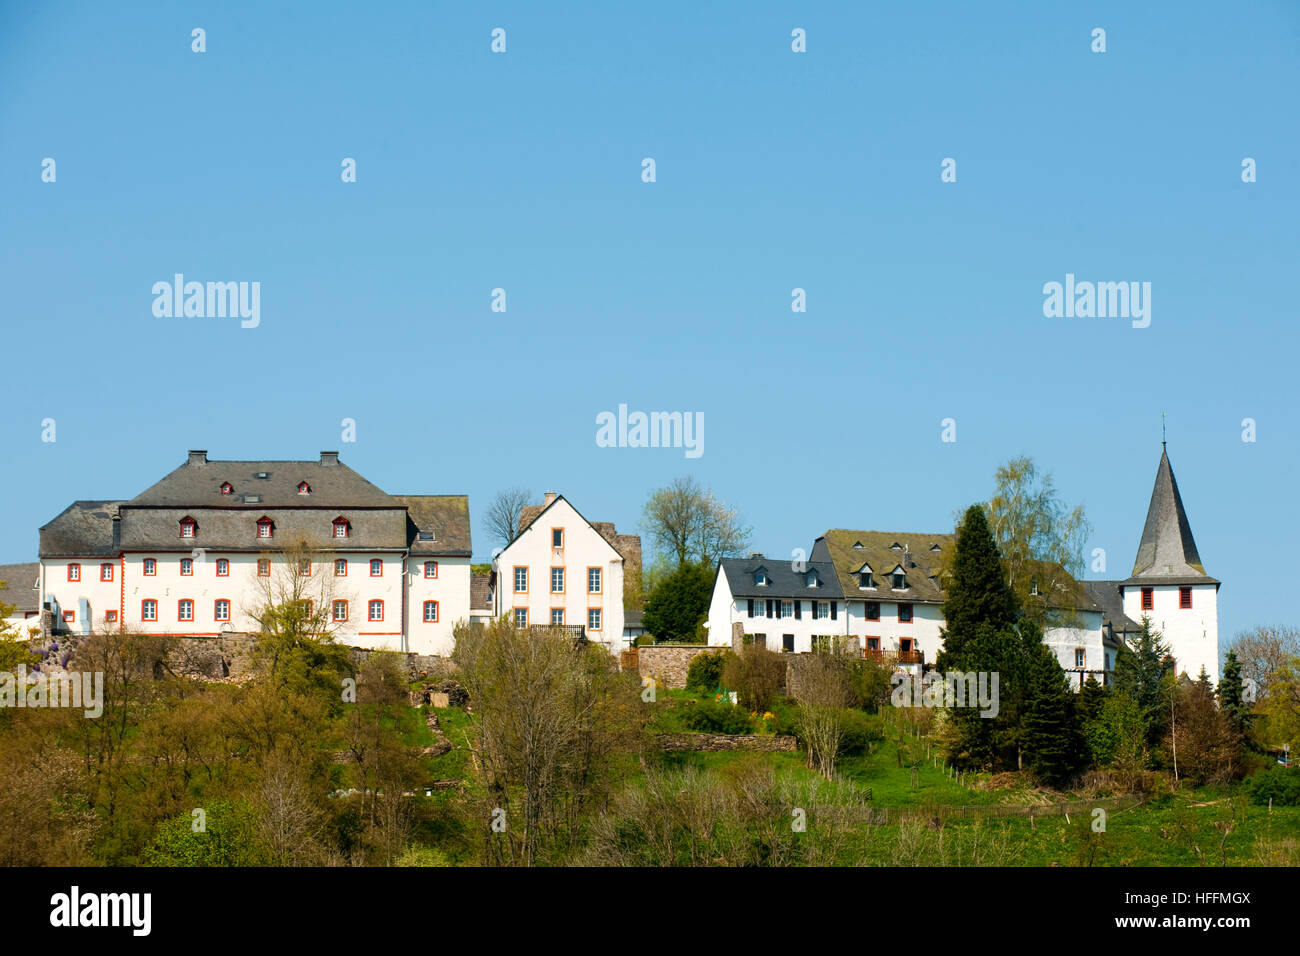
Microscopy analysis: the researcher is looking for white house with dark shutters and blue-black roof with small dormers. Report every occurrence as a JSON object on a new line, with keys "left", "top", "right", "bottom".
{"left": 709, "top": 554, "right": 848, "bottom": 654}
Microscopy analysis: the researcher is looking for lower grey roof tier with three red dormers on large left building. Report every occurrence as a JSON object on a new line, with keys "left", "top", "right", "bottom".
{"left": 121, "top": 501, "right": 407, "bottom": 551}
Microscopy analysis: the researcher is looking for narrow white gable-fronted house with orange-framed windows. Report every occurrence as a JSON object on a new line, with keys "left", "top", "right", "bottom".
{"left": 491, "top": 492, "right": 641, "bottom": 650}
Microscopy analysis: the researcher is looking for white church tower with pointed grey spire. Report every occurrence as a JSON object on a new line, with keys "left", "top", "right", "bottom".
{"left": 1119, "top": 442, "right": 1219, "bottom": 684}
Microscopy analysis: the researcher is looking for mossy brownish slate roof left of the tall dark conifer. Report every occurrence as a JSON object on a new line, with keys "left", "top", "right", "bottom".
{"left": 813, "top": 528, "right": 957, "bottom": 604}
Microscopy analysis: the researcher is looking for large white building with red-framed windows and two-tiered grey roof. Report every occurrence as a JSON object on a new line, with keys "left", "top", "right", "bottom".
{"left": 38, "top": 451, "right": 471, "bottom": 654}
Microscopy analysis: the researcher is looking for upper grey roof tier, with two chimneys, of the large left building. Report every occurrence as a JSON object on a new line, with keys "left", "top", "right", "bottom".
{"left": 130, "top": 451, "right": 395, "bottom": 509}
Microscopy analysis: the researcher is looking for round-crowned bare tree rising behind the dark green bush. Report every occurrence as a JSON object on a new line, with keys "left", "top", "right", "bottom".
{"left": 644, "top": 475, "right": 750, "bottom": 567}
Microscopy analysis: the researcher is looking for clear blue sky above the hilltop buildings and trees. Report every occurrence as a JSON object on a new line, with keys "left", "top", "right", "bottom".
{"left": 0, "top": 0, "right": 1300, "bottom": 650}
